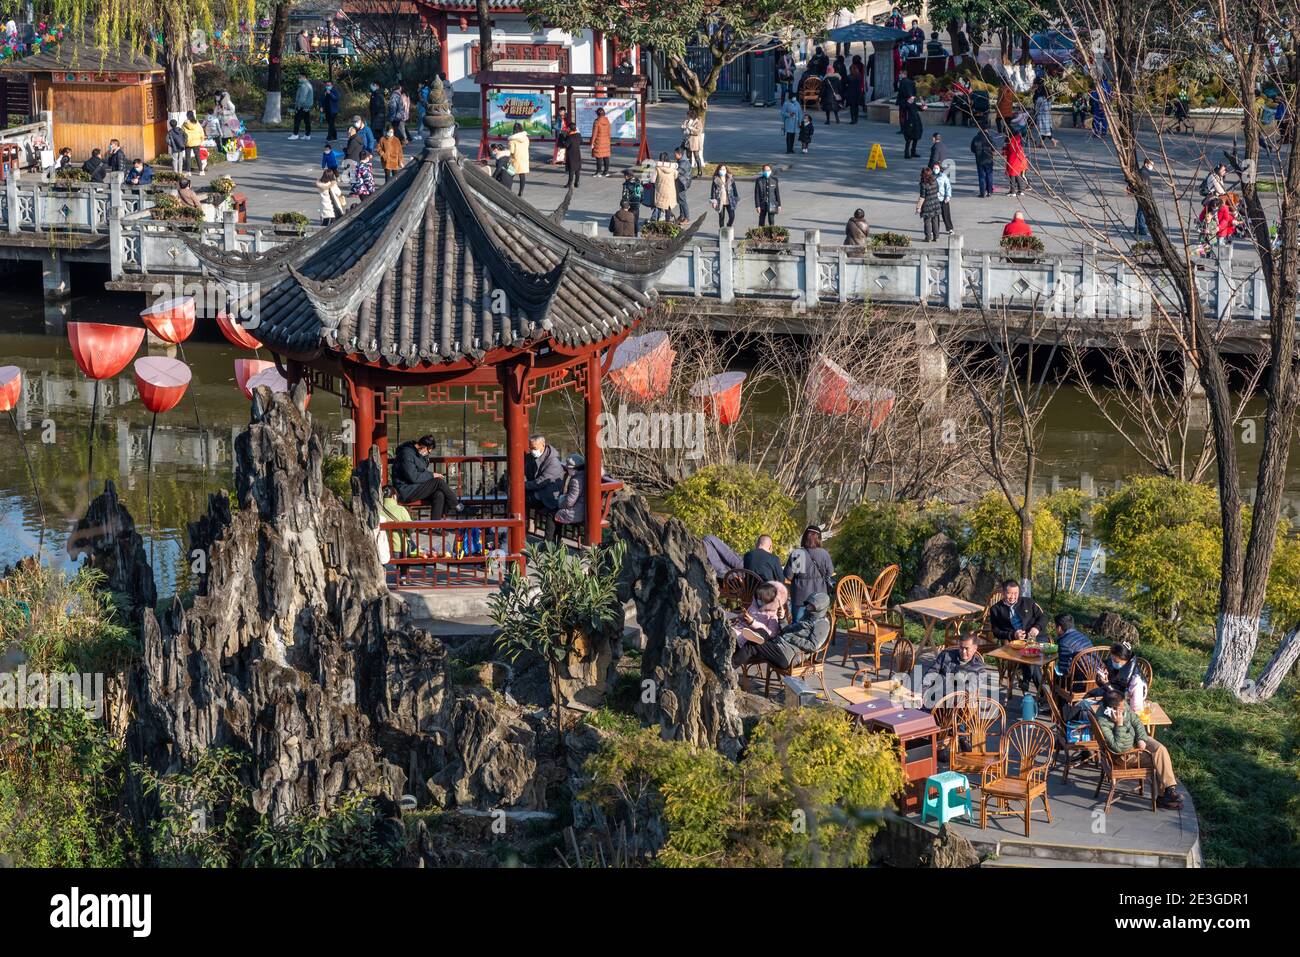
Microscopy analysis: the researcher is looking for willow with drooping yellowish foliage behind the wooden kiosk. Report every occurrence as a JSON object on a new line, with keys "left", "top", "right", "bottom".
{"left": 39, "top": 0, "right": 256, "bottom": 113}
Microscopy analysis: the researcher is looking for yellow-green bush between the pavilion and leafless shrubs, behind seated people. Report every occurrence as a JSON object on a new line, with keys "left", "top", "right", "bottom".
{"left": 666, "top": 465, "right": 800, "bottom": 553}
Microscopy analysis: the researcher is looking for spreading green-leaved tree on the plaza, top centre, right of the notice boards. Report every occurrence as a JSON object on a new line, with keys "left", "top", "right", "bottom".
{"left": 524, "top": 0, "right": 842, "bottom": 134}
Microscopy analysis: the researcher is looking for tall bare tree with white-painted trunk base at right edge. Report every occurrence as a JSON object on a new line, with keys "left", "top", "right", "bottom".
{"left": 1013, "top": 0, "right": 1300, "bottom": 701}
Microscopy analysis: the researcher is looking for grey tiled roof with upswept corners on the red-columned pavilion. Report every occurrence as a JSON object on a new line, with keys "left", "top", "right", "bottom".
{"left": 181, "top": 89, "right": 698, "bottom": 368}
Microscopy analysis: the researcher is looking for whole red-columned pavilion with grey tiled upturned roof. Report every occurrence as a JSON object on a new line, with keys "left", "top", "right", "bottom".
{"left": 187, "top": 85, "right": 693, "bottom": 558}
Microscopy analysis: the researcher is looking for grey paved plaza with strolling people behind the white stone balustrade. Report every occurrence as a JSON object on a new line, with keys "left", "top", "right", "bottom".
{"left": 223, "top": 103, "right": 1242, "bottom": 251}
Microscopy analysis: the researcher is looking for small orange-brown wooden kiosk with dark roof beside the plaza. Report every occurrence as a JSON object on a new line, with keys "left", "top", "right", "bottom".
{"left": 0, "top": 39, "right": 168, "bottom": 161}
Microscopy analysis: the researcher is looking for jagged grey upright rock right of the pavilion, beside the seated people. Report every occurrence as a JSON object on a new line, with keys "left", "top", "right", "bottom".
{"left": 610, "top": 497, "right": 741, "bottom": 757}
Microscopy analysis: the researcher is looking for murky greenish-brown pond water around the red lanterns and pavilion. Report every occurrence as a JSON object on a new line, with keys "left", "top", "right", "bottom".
{"left": 0, "top": 286, "right": 1300, "bottom": 596}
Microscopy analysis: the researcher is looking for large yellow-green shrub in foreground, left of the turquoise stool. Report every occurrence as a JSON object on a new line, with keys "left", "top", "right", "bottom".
{"left": 582, "top": 707, "right": 904, "bottom": 867}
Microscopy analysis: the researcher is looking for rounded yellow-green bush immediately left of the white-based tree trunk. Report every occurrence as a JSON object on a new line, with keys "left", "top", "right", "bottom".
{"left": 1095, "top": 476, "right": 1223, "bottom": 622}
